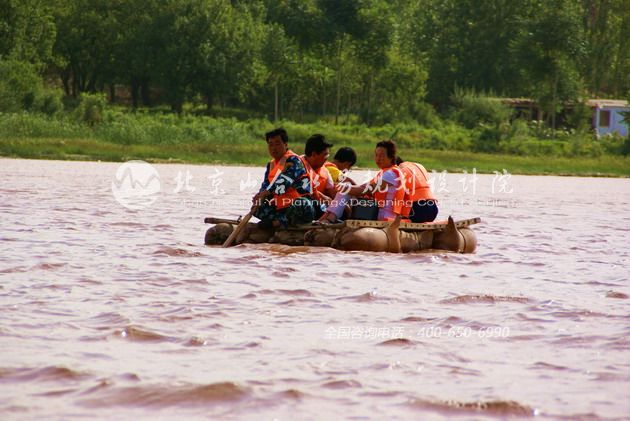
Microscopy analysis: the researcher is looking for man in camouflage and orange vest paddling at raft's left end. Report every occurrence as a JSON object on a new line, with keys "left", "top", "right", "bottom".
{"left": 252, "top": 128, "right": 315, "bottom": 229}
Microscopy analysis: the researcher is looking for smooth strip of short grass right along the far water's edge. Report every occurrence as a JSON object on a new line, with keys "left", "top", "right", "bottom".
{"left": 0, "top": 138, "right": 630, "bottom": 177}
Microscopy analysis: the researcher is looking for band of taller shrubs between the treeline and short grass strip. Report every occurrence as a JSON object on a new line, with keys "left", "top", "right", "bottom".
{"left": 0, "top": 106, "right": 630, "bottom": 161}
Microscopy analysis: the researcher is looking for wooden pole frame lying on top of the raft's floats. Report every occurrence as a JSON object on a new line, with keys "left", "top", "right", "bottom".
{"left": 203, "top": 217, "right": 481, "bottom": 231}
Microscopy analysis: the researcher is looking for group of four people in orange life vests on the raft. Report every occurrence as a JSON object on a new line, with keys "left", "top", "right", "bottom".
{"left": 252, "top": 128, "right": 438, "bottom": 229}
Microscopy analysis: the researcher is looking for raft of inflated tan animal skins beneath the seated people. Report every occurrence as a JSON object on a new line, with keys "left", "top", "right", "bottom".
{"left": 204, "top": 216, "right": 481, "bottom": 253}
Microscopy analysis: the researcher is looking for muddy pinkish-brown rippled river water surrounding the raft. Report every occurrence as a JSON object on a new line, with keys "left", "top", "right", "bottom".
{"left": 0, "top": 159, "right": 630, "bottom": 420}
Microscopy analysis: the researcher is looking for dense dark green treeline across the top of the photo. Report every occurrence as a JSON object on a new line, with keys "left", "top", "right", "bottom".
{"left": 0, "top": 0, "right": 630, "bottom": 124}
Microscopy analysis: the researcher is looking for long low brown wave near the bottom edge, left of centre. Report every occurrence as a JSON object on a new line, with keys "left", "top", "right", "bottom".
{"left": 82, "top": 382, "right": 251, "bottom": 407}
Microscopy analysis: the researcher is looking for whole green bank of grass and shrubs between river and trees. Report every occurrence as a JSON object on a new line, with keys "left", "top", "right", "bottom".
{"left": 0, "top": 109, "right": 630, "bottom": 176}
